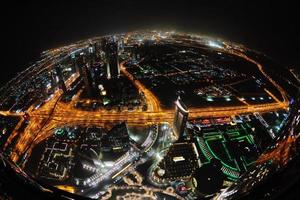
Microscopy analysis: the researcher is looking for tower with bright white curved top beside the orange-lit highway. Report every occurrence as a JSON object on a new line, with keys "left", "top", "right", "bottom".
{"left": 173, "top": 97, "right": 189, "bottom": 139}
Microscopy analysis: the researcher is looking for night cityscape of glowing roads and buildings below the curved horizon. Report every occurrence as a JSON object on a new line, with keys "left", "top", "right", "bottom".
{"left": 0, "top": 30, "right": 300, "bottom": 200}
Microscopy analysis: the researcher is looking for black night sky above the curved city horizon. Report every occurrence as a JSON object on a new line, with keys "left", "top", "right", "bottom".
{"left": 0, "top": 0, "right": 300, "bottom": 85}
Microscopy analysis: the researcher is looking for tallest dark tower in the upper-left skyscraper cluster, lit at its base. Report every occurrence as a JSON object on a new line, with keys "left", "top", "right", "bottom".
{"left": 102, "top": 39, "right": 120, "bottom": 79}
